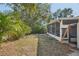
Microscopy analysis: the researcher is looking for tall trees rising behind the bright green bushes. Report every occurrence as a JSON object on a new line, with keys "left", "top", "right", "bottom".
{"left": 9, "top": 3, "right": 51, "bottom": 33}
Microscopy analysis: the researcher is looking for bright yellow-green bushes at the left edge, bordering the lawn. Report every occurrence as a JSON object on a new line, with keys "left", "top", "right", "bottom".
{"left": 0, "top": 14, "right": 31, "bottom": 42}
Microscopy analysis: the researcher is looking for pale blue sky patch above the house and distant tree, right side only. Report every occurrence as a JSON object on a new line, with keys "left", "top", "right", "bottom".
{"left": 51, "top": 3, "right": 79, "bottom": 16}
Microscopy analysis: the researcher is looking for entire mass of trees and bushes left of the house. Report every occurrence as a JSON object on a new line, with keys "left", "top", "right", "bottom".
{"left": 0, "top": 3, "right": 51, "bottom": 41}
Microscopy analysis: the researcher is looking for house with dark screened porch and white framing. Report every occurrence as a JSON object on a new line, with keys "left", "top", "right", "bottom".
{"left": 47, "top": 17, "right": 79, "bottom": 48}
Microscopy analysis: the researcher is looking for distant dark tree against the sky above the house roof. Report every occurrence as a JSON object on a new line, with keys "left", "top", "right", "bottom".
{"left": 53, "top": 8, "right": 73, "bottom": 18}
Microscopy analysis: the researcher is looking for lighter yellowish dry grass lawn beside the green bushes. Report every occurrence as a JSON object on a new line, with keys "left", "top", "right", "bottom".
{"left": 0, "top": 35, "right": 38, "bottom": 56}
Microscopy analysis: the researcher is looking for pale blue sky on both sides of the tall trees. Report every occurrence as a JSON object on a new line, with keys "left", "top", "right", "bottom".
{"left": 0, "top": 3, "right": 79, "bottom": 16}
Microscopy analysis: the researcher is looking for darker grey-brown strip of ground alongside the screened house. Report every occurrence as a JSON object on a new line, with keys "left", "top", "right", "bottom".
{"left": 37, "top": 35, "right": 72, "bottom": 56}
